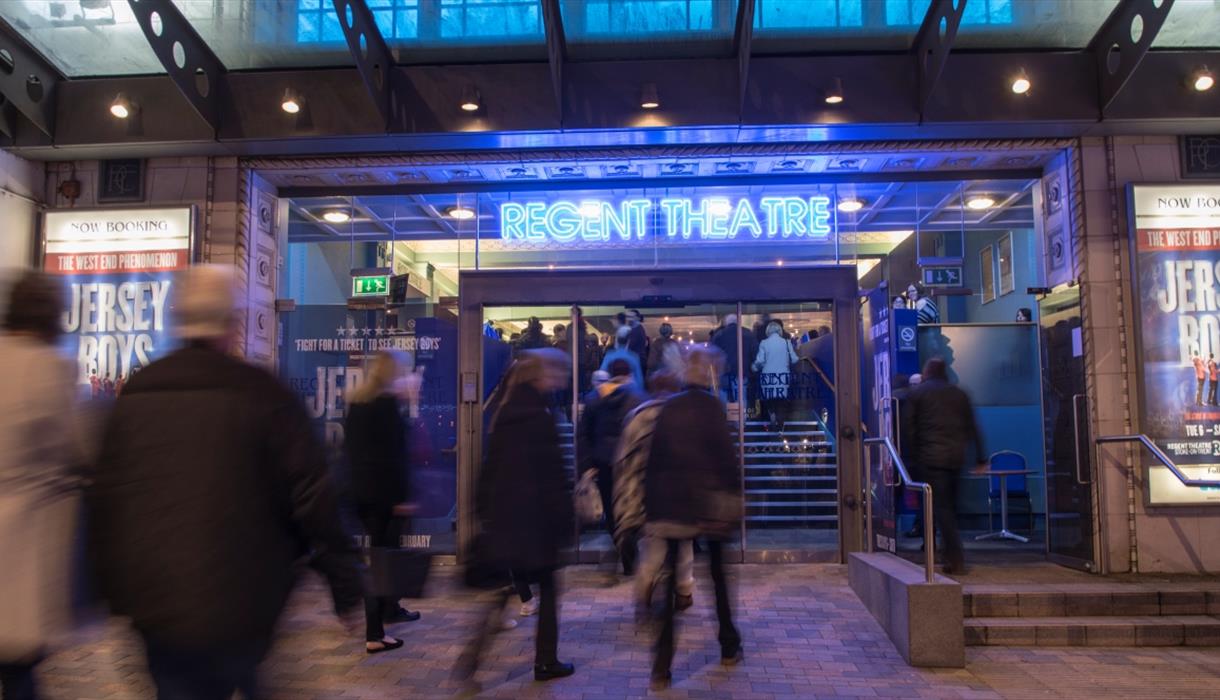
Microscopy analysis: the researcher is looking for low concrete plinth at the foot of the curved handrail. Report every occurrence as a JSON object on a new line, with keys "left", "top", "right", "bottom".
{"left": 848, "top": 552, "right": 966, "bottom": 668}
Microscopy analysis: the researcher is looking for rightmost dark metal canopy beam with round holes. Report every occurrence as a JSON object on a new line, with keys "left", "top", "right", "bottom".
{"left": 1088, "top": 0, "right": 1174, "bottom": 115}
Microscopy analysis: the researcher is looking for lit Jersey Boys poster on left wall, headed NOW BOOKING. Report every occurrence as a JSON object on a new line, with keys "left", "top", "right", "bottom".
{"left": 43, "top": 207, "right": 193, "bottom": 398}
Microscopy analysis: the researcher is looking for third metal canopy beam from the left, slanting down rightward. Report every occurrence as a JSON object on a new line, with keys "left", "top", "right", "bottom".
{"left": 332, "top": 0, "right": 437, "bottom": 133}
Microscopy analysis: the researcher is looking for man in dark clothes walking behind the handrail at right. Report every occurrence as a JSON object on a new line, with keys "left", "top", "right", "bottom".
{"left": 903, "top": 357, "right": 987, "bottom": 573}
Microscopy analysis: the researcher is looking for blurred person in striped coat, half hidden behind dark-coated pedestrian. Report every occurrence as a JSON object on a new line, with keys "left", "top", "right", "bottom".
{"left": 614, "top": 371, "right": 694, "bottom": 618}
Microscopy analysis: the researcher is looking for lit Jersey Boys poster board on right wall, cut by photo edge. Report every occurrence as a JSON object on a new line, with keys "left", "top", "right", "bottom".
{"left": 1130, "top": 185, "right": 1220, "bottom": 505}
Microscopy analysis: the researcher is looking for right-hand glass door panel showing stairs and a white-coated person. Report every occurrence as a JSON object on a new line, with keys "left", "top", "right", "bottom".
{"left": 742, "top": 302, "right": 839, "bottom": 561}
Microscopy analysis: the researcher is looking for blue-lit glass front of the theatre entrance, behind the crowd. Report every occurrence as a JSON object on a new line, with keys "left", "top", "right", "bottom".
{"left": 279, "top": 173, "right": 1043, "bottom": 561}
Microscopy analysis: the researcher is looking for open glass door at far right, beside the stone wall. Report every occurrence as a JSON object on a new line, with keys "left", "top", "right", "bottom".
{"left": 1038, "top": 285, "right": 1097, "bottom": 571}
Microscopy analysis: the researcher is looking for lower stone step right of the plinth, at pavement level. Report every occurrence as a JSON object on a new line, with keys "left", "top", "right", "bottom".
{"left": 965, "top": 615, "right": 1220, "bottom": 646}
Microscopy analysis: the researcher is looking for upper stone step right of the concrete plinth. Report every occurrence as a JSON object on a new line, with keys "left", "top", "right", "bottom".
{"left": 961, "top": 584, "right": 1220, "bottom": 617}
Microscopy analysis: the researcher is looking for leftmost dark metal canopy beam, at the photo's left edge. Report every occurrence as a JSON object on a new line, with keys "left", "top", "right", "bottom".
{"left": 0, "top": 22, "right": 62, "bottom": 138}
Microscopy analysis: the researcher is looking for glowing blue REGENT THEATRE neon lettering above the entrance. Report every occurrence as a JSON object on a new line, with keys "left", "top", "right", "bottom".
{"left": 500, "top": 195, "right": 831, "bottom": 243}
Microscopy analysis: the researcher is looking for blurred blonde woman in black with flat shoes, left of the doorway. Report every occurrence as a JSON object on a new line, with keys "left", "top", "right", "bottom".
{"left": 343, "top": 351, "right": 423, "bottom": 654}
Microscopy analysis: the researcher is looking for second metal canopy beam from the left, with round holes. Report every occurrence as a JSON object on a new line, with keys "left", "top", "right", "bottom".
{"left": 127, "top": 0, "right": 228, "bottom": 134}
